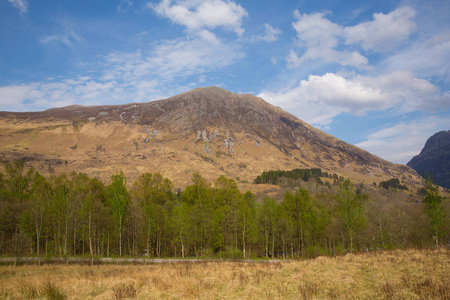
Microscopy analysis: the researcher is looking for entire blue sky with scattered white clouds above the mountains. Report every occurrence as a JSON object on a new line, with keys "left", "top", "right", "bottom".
{"left": 0, "top": 0, "right": 450, "bottom": 163}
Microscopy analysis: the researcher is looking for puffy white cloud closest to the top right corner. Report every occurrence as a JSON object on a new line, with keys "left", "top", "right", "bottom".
{"left": 344, "top": 6, "right": 417, "bottom": 52}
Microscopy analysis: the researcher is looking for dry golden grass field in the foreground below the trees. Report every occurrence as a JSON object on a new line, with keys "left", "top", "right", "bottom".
{"left": 0, "top": 250, "right": 450, "bottom": 299}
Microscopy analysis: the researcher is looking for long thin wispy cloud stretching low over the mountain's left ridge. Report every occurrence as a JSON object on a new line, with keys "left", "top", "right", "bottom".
{"left": 0, "top": 32, "right": 242, "bottom": 111}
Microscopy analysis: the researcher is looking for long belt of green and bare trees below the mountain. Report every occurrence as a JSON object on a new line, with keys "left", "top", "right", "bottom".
{"left": 0, "top": 160, "right": 450, "bottom": 259}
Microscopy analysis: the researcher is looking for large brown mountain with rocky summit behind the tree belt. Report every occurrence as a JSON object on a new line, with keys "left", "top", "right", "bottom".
{"left": 0, "top": 87, "right": 420, "bottom": 186}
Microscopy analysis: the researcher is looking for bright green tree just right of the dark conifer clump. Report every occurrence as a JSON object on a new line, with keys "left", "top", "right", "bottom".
{"left": 337, "top": 179, "right": 366, "bottom": 252}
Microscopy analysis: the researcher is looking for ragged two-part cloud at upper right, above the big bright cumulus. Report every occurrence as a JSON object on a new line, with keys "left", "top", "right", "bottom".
{"left": 287, "top": 7, "right": 416, "bottom": 69}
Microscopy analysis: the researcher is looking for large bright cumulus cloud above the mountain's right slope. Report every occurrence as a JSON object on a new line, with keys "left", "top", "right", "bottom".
{"left": 259, "top": 72, "right": 448, "bottom": 126}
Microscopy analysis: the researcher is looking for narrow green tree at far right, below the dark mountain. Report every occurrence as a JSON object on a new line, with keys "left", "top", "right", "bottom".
{"left": 423, "top": 174, "right": 448, "bottom": 249}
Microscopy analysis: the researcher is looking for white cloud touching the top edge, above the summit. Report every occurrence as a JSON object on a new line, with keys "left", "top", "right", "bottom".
{"left": 148, "top": 0, "right": 248, "bottom": 36}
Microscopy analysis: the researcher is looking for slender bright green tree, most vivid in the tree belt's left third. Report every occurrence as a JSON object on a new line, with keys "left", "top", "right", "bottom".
{"left": 107, "top": 171, "right": 130, "bottom": 256}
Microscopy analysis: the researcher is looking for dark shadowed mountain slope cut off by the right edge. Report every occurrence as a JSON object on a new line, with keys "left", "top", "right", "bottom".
{"left": 407, "top": 130, "right": 450, "bottom": 189}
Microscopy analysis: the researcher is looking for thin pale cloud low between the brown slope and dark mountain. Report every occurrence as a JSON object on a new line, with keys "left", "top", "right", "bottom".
{"left": 356, "top": 116, "right": 449, "bottom": 164}
